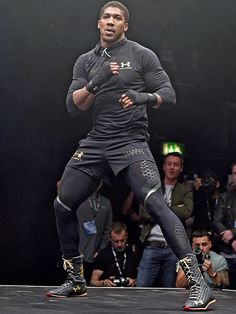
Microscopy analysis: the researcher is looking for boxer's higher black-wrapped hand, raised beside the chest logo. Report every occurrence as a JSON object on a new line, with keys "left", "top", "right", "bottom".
{"left": 86, "top": 62, "right": 119, "bottom": 94}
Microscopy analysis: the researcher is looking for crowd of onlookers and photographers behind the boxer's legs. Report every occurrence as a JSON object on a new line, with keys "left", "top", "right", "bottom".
{"left": 54, "top": 152, "right": 236, "bottom": 289}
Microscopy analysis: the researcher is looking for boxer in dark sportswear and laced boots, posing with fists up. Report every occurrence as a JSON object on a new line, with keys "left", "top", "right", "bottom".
{"left": 48, "top": 1, "right": 215, "bottom": 310}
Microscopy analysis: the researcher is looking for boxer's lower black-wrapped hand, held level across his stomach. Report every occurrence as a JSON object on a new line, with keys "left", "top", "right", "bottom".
{"left": 119, "top": 89, "right": 158, "bottom": 109}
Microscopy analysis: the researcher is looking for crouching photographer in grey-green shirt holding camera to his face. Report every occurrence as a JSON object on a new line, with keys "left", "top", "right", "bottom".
{"left": 176, "top": 230, "right": 229, "bottom": 288}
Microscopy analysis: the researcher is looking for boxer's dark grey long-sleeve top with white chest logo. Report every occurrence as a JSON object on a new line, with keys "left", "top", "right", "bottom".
{"left": 67, "top": 38, "right": 175, "bottom": 140}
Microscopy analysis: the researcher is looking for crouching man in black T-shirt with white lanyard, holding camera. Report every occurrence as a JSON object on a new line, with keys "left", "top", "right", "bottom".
{"left": 90, "top": 222, "right": 137, "bottom": 287}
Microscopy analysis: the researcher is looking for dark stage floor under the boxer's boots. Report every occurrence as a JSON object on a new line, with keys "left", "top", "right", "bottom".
{"left": 0, "top": 285, "right": 236, "bottom": 314}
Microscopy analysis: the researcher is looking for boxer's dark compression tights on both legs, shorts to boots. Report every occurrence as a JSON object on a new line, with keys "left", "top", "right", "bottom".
{"left": 54, "top": 161, "right": 192, "bottom": 259}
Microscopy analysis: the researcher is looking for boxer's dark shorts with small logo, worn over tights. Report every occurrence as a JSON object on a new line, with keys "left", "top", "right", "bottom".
{"left": 67, "top": 138, "right": 155, "bottom": 179}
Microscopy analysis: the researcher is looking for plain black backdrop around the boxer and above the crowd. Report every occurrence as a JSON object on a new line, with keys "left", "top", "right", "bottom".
{"left": 0, "top": 0, "right": 236, "bottom": 284}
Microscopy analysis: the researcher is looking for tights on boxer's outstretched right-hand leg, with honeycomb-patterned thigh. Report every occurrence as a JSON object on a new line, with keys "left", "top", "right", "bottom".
{"left": 123, "top": 161, "right": 192, "bottom": 259}
